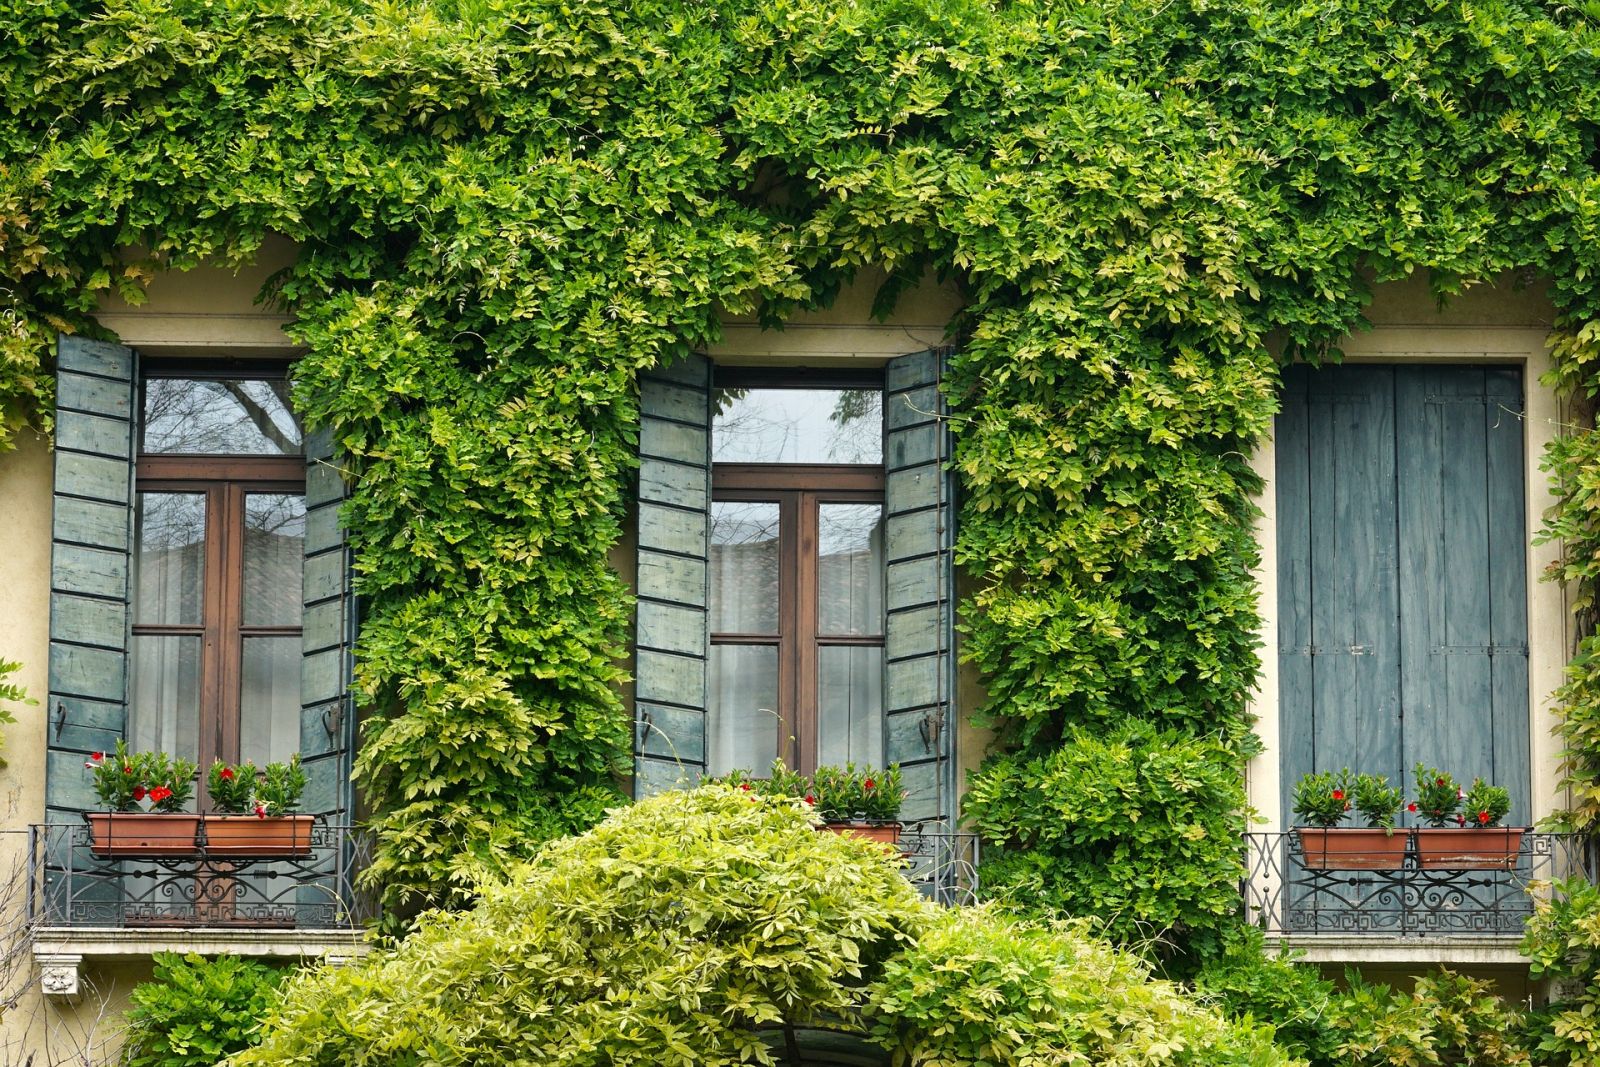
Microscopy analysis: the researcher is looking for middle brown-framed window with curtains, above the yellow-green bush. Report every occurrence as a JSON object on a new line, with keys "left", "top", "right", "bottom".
{"left": 706, "top": 376, "right": 885, "bottom": 774}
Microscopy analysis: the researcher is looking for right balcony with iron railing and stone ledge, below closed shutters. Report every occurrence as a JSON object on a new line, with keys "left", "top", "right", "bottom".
{"left": 1242, "top": 830, "right": 1597, "bottom": 963}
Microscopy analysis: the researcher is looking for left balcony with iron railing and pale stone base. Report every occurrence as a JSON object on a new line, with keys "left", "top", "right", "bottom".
{"left": 26, "top": 819, "right": 376, "bottom": 998}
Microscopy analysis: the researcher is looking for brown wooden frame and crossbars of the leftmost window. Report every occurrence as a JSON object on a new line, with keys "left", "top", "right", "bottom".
{"left": 130, "top": 360, "right": 306, "bottom": 799}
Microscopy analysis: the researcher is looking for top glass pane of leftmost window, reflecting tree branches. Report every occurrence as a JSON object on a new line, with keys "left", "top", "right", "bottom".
{"left": 139, "top": 378, "right": 301, "bottom": 456}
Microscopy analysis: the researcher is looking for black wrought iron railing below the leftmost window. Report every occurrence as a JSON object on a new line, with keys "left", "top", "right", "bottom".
{"left": 29, "top": 819, "right": 374, "bottom": 931}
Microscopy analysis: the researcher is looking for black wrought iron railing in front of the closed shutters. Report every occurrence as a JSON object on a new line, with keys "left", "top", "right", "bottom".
{"left": 1242, "top": 830, "right": 1597, "bottom": 937}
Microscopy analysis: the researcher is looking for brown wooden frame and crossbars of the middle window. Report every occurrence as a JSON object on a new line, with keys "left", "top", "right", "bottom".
{"left": 709, "top": 464, "right": 886, "bottom": 774}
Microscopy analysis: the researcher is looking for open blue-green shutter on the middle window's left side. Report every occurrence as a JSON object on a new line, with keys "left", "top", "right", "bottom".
{"left": 634, "top": 355, "right": 710, "bottom": 797}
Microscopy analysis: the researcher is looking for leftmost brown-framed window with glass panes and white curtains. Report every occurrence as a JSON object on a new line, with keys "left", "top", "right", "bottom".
{"left": 128, "top": 366, "right": 306, "bottom": 790}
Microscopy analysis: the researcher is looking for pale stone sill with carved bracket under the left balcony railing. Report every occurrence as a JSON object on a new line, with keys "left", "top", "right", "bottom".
{"left": 34, "top": 926, "right": 371, "bottom": 1000}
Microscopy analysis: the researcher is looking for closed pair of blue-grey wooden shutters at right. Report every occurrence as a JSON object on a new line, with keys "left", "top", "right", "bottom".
{"left": 1277, "top": 365, "right": 1531, "bottom": 824}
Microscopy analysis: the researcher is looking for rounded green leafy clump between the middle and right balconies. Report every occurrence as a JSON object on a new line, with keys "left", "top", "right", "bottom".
{"left": 965, "top": 721, "right": 1246, "bottom": 944}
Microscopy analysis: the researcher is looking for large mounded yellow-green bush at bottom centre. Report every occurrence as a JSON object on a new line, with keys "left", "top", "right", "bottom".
{"left": 230, "top": 785, "right": 1288, "bottom": 1067}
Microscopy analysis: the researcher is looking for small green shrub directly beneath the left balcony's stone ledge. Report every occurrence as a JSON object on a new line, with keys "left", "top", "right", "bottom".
{"left": 123, "top": 952, "right": 288, "bottom": 1067}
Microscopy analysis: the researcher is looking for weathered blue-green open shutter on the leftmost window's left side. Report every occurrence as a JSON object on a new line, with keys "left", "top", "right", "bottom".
{"left": 45, "top": 336, "right": 138, "bottom": 822}
